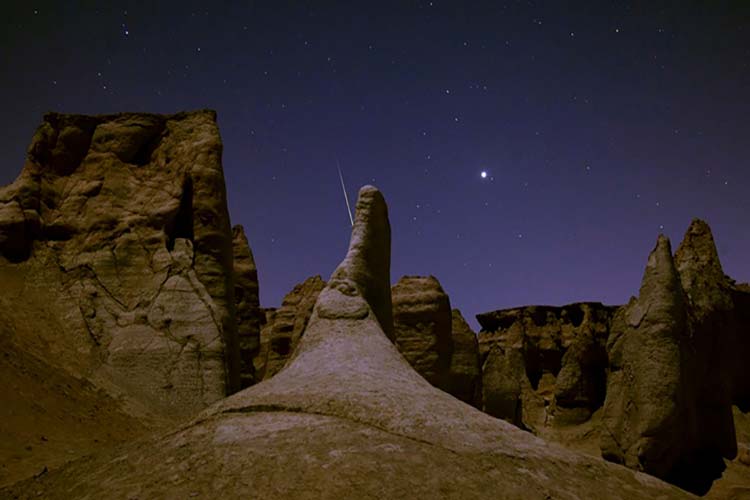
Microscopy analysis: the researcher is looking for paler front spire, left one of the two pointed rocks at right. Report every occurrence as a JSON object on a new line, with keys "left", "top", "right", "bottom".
{"left": 600, "top": 236, "right": 697, "bottom": 484}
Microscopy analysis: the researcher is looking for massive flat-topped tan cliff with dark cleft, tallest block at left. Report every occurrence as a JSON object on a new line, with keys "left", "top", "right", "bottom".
{"left": 0, "top": 111, "right": 239, "bottom": 417}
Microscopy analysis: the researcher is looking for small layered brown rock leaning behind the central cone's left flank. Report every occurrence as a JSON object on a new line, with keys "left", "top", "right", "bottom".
{"left": 255, "top": 276, "right": 326, "bottom": 381}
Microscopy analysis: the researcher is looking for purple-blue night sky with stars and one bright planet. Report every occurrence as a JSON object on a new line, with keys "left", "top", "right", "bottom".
{"left": 0, "top": 0, "right": 750, "bottom": 327}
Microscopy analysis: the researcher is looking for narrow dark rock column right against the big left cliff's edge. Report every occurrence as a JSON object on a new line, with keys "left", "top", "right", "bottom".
{"left": 232, "top": 226, "right": 265, "bottom": 388}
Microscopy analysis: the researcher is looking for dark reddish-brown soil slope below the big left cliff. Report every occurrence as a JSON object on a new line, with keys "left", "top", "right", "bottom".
{"left": 0, "top": 336, "right": 147, "bottom": 487}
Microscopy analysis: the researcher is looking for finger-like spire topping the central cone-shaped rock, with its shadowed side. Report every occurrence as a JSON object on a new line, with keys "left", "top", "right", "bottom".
{"left": 329, "top": 185, "right": 393, "bottom": 340}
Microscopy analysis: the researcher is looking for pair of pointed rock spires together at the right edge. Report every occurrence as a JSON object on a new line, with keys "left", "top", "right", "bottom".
{"left": 601, "top": 224, "right": 750, "bottom": 493}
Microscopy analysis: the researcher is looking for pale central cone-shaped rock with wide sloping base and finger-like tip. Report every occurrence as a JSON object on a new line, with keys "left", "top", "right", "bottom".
{"left": 2, "top": 187, "right": 687, "bottom": 499}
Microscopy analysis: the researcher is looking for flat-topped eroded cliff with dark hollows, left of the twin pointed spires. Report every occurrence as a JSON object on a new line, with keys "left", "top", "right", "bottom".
{"left": 477, "top": 302, "right": 616, "bottom": 436}
